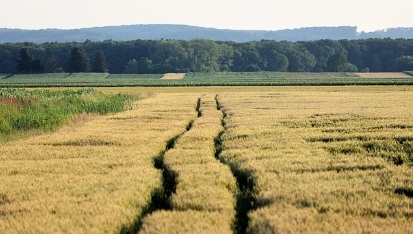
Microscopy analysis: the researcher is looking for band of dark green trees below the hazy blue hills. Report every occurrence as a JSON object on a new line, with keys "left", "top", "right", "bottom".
{"left": 0, "top": 38, "right": 413, "bottom": 74}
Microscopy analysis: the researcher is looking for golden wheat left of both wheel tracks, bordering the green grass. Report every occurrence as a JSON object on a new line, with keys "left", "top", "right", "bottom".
{"left": 0, "top": 94, "right": 197, "bottom": 233}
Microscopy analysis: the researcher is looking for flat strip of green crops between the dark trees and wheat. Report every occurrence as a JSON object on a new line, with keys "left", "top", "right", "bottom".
{"left": 0, "top": 72, "right": 413, "bottom": 87}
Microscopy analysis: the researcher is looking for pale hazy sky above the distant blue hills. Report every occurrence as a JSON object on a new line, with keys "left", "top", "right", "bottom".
{"left": 0, "top": 0, "right": 413, "bottom": 31}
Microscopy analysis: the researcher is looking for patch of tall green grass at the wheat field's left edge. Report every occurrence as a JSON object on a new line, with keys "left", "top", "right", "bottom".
{"left": 0, "top": 89, "right": 132, "bottom": 141}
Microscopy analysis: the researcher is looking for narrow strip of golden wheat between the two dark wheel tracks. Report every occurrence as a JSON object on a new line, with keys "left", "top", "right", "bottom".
{"left": 141, "top": 94, "right": 237, "bottom": 233}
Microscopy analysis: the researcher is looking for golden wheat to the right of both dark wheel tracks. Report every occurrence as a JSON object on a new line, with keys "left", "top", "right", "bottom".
{"left": 220, "top": 87, "right": 413, "bottom": 233}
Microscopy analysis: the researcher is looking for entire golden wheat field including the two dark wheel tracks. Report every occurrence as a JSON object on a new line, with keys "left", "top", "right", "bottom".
{"left": 0, "top": 85, "right": 413, "bottom": 233}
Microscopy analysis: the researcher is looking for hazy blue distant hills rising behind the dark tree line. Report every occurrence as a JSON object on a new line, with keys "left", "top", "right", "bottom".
{"left": 0, "top": 24, "right": 413, "bottom": 43}
